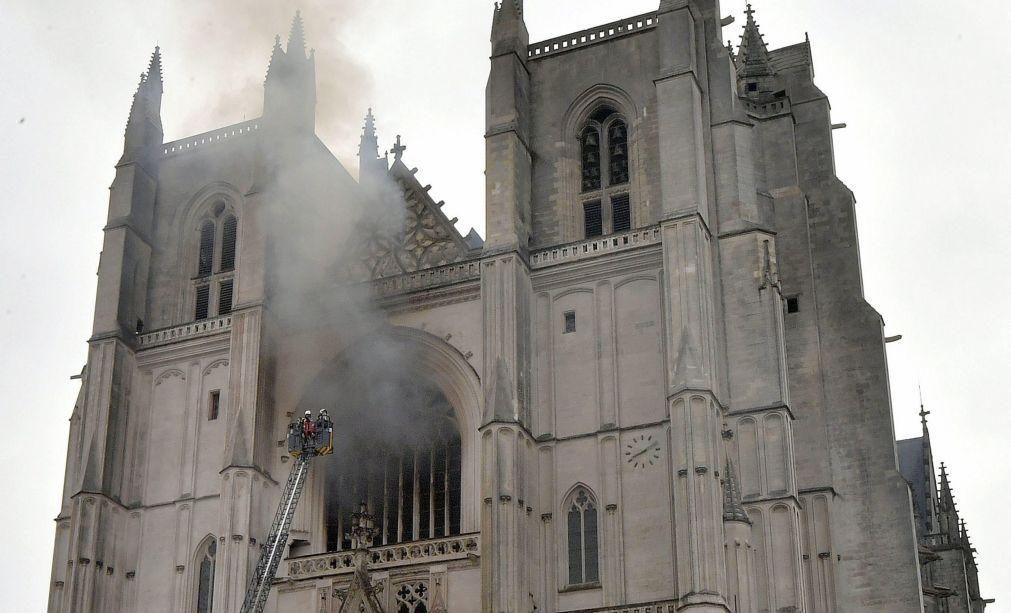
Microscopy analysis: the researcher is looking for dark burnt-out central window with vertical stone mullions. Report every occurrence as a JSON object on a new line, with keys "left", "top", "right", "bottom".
{"left": 327, "top": 407, "right": 462, "bottom": 551}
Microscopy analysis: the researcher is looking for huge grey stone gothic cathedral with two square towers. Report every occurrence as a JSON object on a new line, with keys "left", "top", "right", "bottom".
{"left": 49, "top": 0, "right": 990, "bottom": 613}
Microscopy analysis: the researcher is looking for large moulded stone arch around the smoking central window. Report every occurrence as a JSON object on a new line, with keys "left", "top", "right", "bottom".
{"left": 298, "top": 327, "right": 483, "bottom": 533}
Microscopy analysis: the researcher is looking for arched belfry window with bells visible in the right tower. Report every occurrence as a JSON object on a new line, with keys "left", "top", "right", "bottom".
{"left": 579, "top": 105, "right": 632, "bottom": 239}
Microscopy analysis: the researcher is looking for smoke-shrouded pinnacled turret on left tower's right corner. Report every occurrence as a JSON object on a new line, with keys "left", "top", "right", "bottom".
{"left": 263, "top": 12, "right": 316, "bottom": 134}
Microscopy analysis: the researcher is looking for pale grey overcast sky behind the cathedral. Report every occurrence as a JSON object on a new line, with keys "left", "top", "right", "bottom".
{"left": 0, "top": 0, "right": 1011, "bottom": 611}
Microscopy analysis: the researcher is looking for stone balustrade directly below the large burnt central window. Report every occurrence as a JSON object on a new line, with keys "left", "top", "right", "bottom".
{"left": 288, "top": 533, "right": 481, "bottom": 579}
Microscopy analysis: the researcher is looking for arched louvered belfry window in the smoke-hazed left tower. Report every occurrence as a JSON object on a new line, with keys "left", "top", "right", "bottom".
{"left": 193, "top": 202, "right": 239, "bottom": 321}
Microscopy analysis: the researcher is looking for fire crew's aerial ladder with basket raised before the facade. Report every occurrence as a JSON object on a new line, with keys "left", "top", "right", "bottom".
{"left": 242, "top": 409, "right": 334, "bottom": 613}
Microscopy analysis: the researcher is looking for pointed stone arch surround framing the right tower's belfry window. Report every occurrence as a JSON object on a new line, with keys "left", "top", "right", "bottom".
{"left": 557, "top": 83, "right": 646, "bottom": 243}
